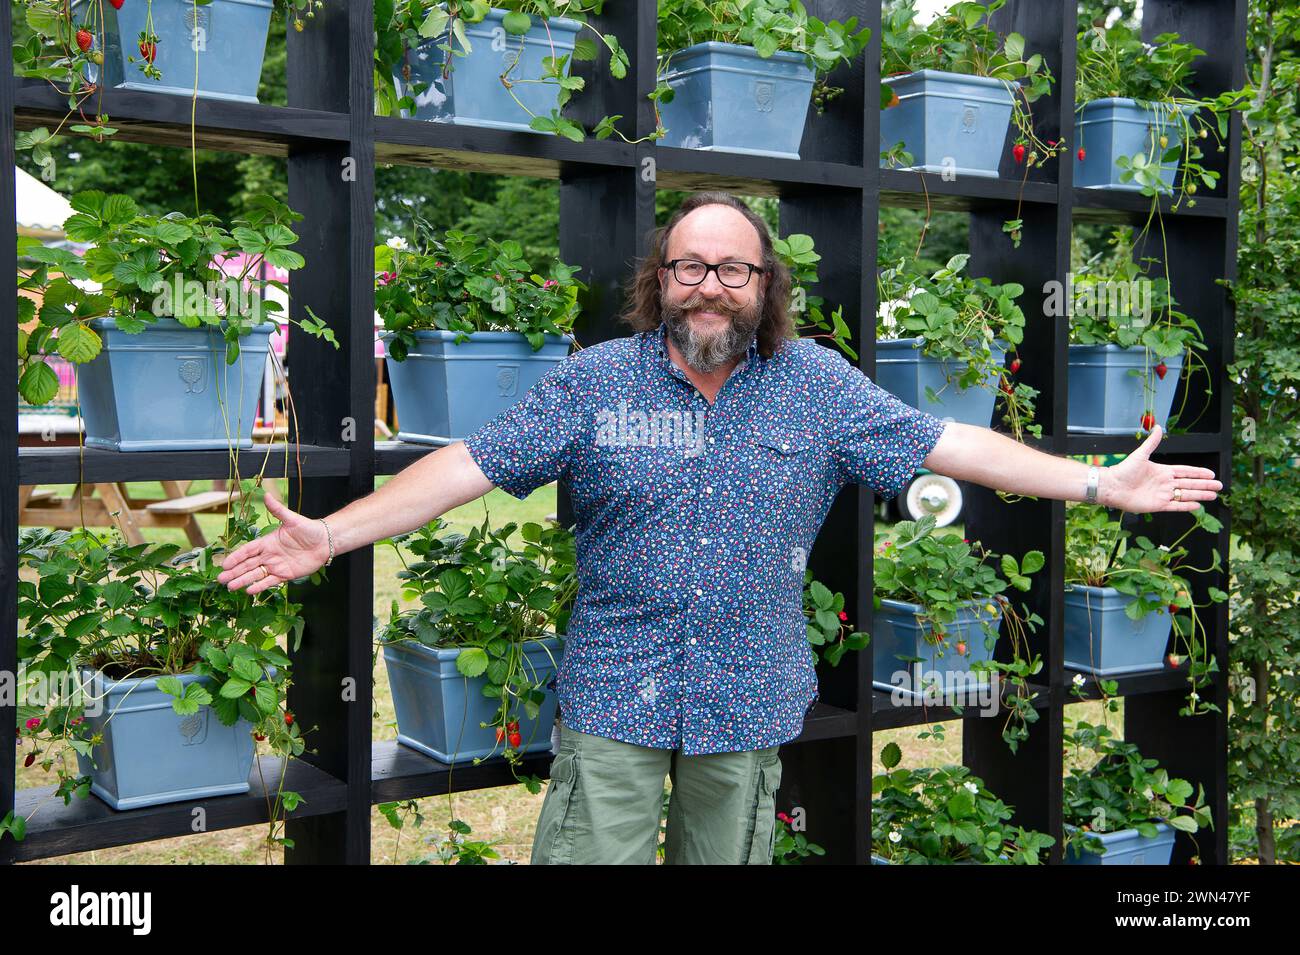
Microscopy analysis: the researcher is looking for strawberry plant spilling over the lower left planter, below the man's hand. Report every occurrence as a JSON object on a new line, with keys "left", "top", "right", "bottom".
{"left": 9, "top": 512, "right": 312, "bottom": 854}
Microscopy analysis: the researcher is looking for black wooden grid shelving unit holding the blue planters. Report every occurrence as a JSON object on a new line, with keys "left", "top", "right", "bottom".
{"left": 0, "top": 0, "right": 1245, "bottom": 864}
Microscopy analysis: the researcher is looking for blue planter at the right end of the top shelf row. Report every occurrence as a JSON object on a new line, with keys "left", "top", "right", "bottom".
{"left": 1074, "top": 96, "right": 1195, "bottom": 192}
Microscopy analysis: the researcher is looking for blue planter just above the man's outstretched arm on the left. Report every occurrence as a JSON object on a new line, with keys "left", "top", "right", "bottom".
{"left": 380, "top": 330, "right": 568, "bottom": 444}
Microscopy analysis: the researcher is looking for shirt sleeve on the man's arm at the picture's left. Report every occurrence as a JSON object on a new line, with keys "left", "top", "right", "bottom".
{"left": 464, "top": 356, "right": 581, "bottom": 500}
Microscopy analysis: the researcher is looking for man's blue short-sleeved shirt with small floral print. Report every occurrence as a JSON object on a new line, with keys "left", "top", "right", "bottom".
{"left": 464, "top": 324, "right": 944, "bottom": 755}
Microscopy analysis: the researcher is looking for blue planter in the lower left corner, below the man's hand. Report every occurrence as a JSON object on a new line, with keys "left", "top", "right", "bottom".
{"left": 77, "top": 670, "right": 254, "bottom": 809}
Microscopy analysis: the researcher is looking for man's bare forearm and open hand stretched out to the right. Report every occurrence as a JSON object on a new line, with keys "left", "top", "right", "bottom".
{"left": 924, "top": 421, "right": 1223, "bottom": 513}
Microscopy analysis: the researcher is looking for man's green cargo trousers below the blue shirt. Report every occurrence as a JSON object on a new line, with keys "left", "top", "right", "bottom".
{"left": 532, "top": 722, "right": 781, "bottom": 865}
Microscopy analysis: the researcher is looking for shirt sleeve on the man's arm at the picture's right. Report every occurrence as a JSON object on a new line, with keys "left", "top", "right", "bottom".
{"left": 831, "top": 355, "right": 948, "bottom": 499}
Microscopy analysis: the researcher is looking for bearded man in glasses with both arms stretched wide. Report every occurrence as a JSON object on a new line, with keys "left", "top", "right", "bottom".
{"left": 218, "top": 192, "right": 1222, "bottom": 864}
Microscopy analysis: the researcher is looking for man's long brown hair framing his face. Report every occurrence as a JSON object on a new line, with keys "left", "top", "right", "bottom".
{"left": 619, "top": 192, "right": 794, "bottom": 359}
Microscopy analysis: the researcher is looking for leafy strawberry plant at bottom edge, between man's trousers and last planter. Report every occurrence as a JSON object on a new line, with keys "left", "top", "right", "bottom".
{"left": 871, "top": 743, "right": 1056, "bottom": 865}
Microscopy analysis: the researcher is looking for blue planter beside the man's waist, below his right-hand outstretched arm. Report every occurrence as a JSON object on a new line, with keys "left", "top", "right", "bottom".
{"left": 871, "top": 598, "right": 1002, "bottom": 702}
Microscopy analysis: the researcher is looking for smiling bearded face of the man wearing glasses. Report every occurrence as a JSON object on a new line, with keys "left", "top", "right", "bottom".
{"left": 659, "top": 205, "right": 768, "bottom": 374}
